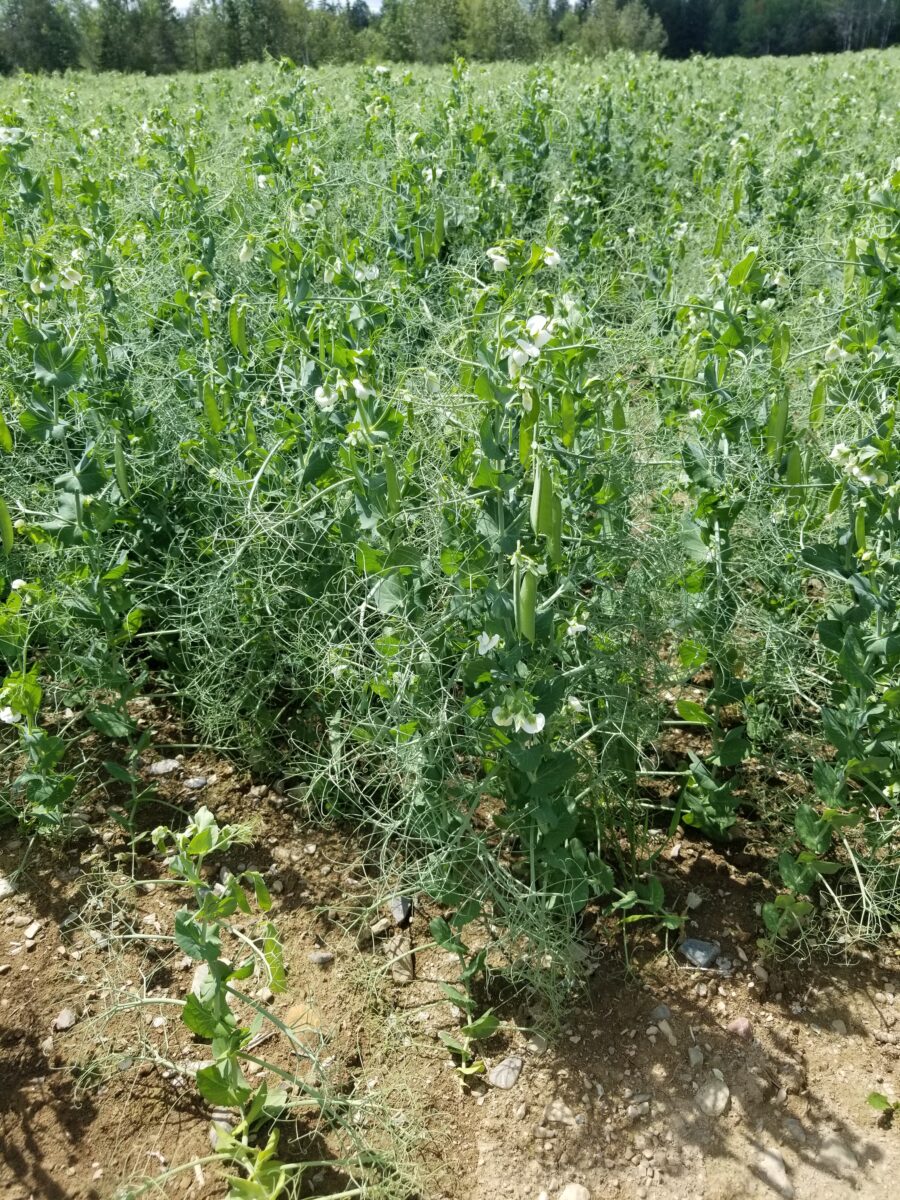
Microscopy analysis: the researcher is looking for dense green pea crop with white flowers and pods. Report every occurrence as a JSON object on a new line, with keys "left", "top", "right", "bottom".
{"left": 0, "top": 52, "right": 900, "bottom": 1198}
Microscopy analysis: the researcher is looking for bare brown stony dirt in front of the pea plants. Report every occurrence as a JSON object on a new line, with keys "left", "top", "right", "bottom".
{"left": 0, "top": 710, "right": 900, "bottom": 1200}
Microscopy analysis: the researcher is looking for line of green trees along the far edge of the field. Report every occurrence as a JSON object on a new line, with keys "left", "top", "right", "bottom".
{"left": 0, "top": 0, "right": 900, "bottom": 74}
